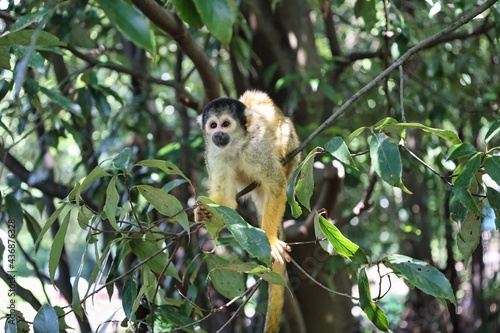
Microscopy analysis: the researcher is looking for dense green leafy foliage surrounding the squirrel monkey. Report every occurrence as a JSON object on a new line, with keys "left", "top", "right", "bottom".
{"left": 0, "top": 0, "right": 500, "bottom": 332}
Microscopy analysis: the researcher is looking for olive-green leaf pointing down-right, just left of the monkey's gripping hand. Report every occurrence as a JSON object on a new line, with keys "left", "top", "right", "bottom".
{"left": 135, "top": 185, "right": 189, "bottom": 231}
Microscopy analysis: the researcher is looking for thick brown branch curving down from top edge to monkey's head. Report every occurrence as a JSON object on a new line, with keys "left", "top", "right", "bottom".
{"left": 132, "top": 0, "right": 220, "bottom": 100}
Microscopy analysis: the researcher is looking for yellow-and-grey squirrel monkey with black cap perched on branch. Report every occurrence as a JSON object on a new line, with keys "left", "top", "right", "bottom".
{"left": 195, "top": 91, "right": 300, "bottom": 333}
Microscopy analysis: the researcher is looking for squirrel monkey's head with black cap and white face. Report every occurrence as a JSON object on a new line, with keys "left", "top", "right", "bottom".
{"left": 200, "top": 98, "right": 247, "bottom": 148}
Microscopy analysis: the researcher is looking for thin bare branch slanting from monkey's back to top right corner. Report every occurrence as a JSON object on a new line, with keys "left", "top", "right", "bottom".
{"left": 284, "top": 0, "right": 498, "bottom": 163}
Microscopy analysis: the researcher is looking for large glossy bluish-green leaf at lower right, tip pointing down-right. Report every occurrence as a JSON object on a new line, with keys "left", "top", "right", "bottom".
{"left": 383, "top": 254, "right": 457, "bottom": 306}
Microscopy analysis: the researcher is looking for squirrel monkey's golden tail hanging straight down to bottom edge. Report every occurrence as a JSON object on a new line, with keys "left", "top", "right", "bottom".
{"left": 264, "top": 262, "right": 286, "bottom": 333}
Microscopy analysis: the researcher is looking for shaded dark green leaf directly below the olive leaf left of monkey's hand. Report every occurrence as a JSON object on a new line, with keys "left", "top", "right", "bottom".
{"left": 129, "top": 238, "right": 180, "bottom": 281}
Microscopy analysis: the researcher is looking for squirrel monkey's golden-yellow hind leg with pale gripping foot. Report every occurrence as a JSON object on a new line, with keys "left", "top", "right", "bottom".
{"left": 261, "top": 190, "right": 291, "bottom": 265}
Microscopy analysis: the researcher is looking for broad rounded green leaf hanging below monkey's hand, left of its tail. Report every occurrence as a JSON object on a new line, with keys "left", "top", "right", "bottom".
{"left": 206, "top": 254, "right": 245, "bottom": 299}
